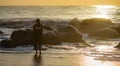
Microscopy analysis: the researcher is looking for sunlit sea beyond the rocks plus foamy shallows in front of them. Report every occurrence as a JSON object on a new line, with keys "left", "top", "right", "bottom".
{"left": 0, "top": 6, "right": 120, "bottom": 63}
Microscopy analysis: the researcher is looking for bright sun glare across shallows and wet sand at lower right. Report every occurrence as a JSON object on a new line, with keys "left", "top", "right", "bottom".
{"left": 79, "top": 45, "right": 119, "bottom": 66}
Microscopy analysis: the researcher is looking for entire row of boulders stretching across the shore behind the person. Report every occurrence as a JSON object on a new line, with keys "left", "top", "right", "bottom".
{"left": 0, "top": 18, "right": 120, "bottom": 48}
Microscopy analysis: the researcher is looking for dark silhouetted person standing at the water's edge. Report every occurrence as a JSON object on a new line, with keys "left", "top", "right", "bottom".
{"left": 33, "top": 19, "right": 43, "bottom": 55}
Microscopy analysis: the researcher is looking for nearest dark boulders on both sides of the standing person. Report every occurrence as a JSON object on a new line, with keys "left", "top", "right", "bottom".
{"left": 0, "top": 25, "right": 84, "bottom": 48}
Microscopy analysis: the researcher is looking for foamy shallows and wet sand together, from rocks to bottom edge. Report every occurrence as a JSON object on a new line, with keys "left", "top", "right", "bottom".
{"left": 0, "top": 40, "right": 120, "bottom": 66}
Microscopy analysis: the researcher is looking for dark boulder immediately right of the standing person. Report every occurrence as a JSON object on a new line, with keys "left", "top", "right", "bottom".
{"left": 43, "top": 26, "right": 61, "bottom": 44}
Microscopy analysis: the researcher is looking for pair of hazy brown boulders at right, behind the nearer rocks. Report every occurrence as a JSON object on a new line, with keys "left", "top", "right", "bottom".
{"left": 70, "top": 18, "right": 120, "bottom": 39}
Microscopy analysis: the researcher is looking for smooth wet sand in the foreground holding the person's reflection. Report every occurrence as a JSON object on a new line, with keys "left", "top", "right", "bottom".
{"left": 0, "top": 53, "right": 120, "bottom": 66}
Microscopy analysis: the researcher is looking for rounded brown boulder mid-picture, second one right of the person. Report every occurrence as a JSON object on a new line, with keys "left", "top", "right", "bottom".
{"left": 57, "top": 25, "right": 83, "bottom": 42}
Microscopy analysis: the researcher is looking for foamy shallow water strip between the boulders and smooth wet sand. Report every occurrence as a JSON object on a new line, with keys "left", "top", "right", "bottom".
{"left": 0, "top": 41, "right": 120, "bottom": 61}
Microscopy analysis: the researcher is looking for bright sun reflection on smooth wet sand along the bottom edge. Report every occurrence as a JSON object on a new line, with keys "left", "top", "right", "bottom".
{"left": 78, "top": 56, "right": 114, "bottom": 66}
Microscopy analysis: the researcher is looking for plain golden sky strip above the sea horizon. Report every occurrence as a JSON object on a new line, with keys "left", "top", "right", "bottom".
{"left": 0, "top": 0, "right": 120, "bottom": 6}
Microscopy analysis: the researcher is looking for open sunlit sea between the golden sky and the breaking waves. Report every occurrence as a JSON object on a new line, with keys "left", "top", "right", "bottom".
{"left": 0, "top": 6, "right": 120, "bottom": 22}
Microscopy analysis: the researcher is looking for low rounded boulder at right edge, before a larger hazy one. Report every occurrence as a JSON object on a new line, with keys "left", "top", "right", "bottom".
{"left": 89, "top": 27, "right": 119, "bottom": 39}
